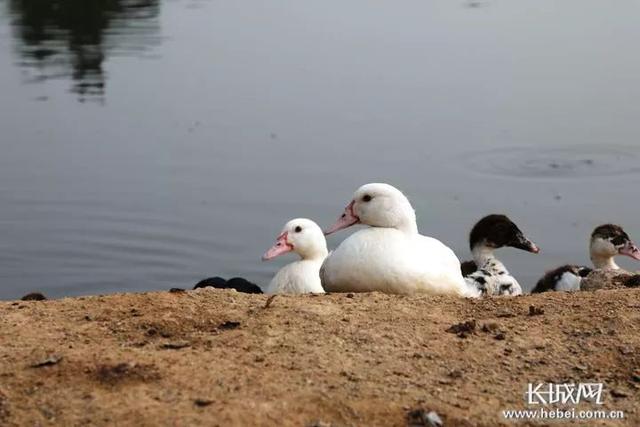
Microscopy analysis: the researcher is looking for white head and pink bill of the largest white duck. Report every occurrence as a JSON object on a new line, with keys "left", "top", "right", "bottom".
{"left": 325, "top": 183, "right": 418, "bottom": 235}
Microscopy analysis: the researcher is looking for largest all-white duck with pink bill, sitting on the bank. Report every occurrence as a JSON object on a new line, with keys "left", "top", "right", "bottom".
{"left": 320, "top": 184, "right": 479, "bottom": 297}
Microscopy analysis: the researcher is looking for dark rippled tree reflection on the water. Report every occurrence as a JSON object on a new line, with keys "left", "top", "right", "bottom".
{"left": 9, "top": 0, "right": 160, "bottom": 101}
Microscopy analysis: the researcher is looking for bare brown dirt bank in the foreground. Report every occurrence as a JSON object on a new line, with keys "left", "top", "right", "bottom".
{"left": 0, "top": 288, "right": 640, "bottom": 426}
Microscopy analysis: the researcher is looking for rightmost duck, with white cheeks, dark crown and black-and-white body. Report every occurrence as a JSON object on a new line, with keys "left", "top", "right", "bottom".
{"left": 531, "top": 224, "right": 640, "bottom": 293}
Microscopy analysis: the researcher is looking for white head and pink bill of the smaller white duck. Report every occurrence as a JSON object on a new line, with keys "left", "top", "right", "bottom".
{"left": 262, "top": 218, "right": 328, "bottom": 261}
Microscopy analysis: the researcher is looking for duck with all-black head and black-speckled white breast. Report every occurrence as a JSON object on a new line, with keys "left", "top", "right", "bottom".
{"left": 461, "top": 214, "right": 540, "bottom": 295}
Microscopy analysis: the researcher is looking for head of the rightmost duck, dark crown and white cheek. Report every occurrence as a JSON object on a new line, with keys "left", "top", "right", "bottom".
{"left": 589, "top": 224, "right": 640, "bottom": 269}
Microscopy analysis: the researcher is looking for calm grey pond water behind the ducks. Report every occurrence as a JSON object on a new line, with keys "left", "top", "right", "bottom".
{"left": 0, "top": 0, "right": 640, "bottom": 299}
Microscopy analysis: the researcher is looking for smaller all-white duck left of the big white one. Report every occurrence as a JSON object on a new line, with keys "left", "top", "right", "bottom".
{"left": 262, "top": 218, "right": 329, "bottom": 294}
